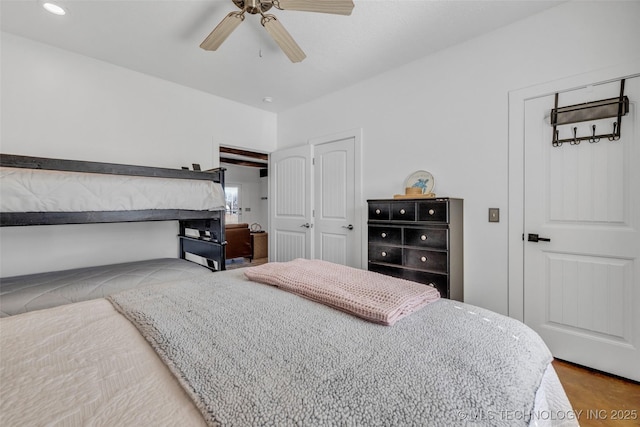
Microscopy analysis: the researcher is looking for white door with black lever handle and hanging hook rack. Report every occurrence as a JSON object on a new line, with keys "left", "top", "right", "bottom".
{"left": 523, "top": 77, "right": 640, "bottom": 381}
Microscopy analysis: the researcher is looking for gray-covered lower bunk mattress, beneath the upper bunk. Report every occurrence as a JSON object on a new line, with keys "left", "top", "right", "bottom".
{"left": 0, "top": 258, "right": 211, "bottom": 317}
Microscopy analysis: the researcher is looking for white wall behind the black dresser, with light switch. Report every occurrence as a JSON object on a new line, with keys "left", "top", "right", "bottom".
{"left": 278, "top": 1, "right": 640, "bottom": 314}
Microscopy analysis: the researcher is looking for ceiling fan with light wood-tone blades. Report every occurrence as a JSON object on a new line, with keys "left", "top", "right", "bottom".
{"left": 200, "top": 0, "right": 353, "bottom": 62}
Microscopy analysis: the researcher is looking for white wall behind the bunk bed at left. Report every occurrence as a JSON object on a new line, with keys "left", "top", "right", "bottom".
{"left": 0, "top": 33, "right": 276, "bottom": 277}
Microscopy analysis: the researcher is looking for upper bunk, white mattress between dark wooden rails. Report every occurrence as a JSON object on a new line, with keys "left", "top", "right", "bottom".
{"left": 0, "top": 154, "right": 225, "bottom": 227}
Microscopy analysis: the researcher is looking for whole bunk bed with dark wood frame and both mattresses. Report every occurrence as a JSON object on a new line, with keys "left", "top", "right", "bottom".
{"left": 0, "top": 154, "right": 226, "bottom": 316}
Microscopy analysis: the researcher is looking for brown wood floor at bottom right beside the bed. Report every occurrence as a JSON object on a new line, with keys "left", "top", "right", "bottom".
{"left": 553, "top": 359, "right": 640, "bottom": 427}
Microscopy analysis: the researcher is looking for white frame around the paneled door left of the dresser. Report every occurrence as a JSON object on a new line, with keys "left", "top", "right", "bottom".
{"left": 307, "top": 128, "right": 367, "bottom": 268}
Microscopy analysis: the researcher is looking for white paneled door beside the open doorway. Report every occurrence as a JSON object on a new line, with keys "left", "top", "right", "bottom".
{"left": 269, "top": 145, "right": 313, "bottom": 262}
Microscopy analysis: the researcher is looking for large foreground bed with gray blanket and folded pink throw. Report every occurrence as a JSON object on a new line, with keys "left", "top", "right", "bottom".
{"left": 0, "top": 155, "right": 577, "bottom": 426}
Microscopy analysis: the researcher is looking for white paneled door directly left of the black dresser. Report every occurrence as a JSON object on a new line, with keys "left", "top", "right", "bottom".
{"left": 313, "top": 137, "right": 361, "bottom": 267}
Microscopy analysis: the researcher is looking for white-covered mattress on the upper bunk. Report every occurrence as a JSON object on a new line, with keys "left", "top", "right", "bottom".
{"left": 0, "top": 167, "right": 225, "bottom": 212}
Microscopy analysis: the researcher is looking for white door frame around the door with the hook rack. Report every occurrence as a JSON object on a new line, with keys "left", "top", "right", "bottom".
{"left": 507, "top": 59, "right": 640, "bottom": 322}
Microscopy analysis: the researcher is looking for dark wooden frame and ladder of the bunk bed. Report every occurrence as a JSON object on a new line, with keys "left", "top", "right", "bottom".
{"left": 0, "top": 154, "right": 226, "bottom": 270}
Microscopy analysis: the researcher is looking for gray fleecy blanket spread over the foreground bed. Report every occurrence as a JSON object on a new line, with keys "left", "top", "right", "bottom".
{"left": 109, "top": 269, "right": 551, "bottom": 426}
